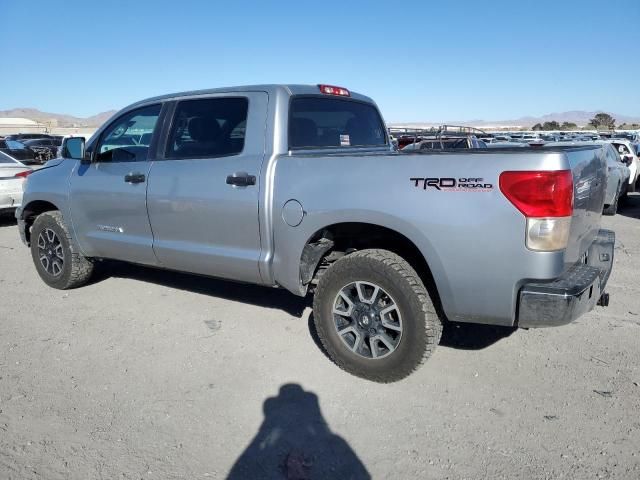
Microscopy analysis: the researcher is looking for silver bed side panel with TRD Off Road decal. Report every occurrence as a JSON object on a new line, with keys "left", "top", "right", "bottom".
{"left": 273, "top": 151, "right": 601, "bottom": 325}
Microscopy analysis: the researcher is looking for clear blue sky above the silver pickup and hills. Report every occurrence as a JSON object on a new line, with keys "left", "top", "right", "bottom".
{"left": 0, "top": 0, "right": 640, "bottom": 122}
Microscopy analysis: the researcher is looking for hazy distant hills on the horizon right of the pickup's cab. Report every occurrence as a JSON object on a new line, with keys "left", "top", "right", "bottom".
{"left": 391, "top": 110, "right": 640, "bottom": 128}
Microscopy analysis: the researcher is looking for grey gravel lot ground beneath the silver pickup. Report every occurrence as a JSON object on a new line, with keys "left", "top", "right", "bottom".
{"left": 0, "top": 195, "right": 640, "bottom": 479}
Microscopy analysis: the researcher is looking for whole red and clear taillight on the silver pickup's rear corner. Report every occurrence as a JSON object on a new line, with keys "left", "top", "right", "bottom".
{"left": 500, "top": 170, "right": 573, "bottom": 251}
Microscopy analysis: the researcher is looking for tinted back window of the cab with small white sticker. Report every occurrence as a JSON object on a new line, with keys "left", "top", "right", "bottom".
{"left": 289, "top": 96, "right": 387, "bottom": 149}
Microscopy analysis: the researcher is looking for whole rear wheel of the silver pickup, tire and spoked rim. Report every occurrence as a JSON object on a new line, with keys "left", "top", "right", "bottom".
{"left": 313, "top": 249, "right": 442, "bottom": 383}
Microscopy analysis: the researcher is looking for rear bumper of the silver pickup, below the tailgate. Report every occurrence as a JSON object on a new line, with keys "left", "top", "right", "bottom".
{"left": 517, "top": 230, "right": 616, "bottom": 328}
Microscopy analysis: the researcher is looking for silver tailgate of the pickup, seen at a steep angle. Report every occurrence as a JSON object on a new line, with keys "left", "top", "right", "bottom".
{"left": 563, "top": 146, "right": 607, "bottom": 264}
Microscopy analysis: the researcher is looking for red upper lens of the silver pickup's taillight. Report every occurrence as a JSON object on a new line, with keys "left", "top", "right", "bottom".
{"left": 500, "top": 170, "right": 573, "bottom": 218}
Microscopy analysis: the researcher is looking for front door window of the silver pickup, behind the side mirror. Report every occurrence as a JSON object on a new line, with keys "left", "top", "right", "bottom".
{"left": 96, "top": 105, "right": 162, "bottom": 162}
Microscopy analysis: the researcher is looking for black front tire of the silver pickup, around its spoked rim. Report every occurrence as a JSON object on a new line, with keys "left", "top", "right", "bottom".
{"left": 31, "top": 211, "right": 94, "bottom": 290}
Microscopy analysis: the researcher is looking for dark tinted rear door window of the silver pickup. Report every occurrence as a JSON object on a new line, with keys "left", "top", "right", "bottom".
{"left": 165, "top": 97, "right": 249, "bottom": 158}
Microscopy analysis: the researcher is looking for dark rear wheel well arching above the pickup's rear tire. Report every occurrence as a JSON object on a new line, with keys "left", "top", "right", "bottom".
{"left": 300, "top": 223, "right": 440, "bottom": 309}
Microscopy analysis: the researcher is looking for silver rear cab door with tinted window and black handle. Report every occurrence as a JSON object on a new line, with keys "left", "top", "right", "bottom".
{"left": 147, "top": 92, "right": 268, "bottom": 282}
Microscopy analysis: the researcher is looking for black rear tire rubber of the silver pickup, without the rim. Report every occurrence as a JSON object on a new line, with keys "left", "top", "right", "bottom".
{"left": 313, "top": 249, "right": 442, "bottom": 383}
